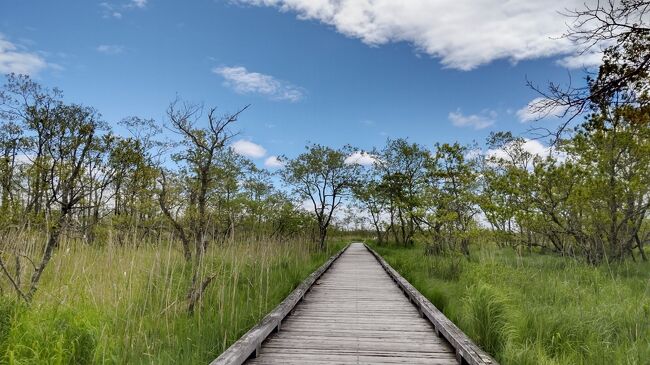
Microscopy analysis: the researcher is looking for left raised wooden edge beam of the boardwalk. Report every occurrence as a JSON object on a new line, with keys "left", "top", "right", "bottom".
{"left": 210, "top": 244, "right": 350, "bottom": 365}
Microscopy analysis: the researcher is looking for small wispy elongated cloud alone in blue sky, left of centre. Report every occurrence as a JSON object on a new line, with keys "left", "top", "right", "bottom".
{"left": 212, "top": 66, "right": 304, "bottom": 102}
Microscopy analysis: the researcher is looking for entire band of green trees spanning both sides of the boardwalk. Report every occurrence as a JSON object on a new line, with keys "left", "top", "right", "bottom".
{"left": 0, "top": 0, "right": 650, "bottom": 312}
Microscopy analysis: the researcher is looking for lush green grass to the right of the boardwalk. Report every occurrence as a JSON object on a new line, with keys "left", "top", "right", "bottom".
{"left": 374, "top": 240, "right": 650, "bottom": 365}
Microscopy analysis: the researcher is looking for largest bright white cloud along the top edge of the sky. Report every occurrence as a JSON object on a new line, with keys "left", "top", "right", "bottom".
{"left": 235, "top": 0, "right": 595, "bottom": 70}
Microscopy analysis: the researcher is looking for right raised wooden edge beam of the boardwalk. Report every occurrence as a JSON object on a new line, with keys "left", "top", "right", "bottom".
{"left": 364, "top": 244, "right": 499, "bottom": 365}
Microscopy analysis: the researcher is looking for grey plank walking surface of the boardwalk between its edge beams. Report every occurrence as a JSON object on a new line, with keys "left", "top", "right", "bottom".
{"left": 247, "top": 243, "right": 458, "bottom": 364}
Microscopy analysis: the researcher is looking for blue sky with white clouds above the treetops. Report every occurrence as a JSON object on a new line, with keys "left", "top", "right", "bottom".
{"left": 0, "top": 0, "right": 598, "bottom": 165}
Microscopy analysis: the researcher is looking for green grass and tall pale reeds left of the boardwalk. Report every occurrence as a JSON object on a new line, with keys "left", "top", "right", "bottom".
{"left": 0, "top": 232, "right": 342, "bottom": 364}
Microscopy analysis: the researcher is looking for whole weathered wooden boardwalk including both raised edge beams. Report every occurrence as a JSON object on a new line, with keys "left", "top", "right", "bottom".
{"left": 212, "top": 244, "right": 498, "bottom": 365}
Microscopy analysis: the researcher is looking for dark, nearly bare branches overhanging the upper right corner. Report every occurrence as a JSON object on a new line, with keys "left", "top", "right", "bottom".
{"left": 528, "top": 0, "right": 650, "bottom": 140}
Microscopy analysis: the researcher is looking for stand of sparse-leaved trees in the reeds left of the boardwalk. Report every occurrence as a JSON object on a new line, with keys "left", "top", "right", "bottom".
{"left": 0, "top": 74, "right": 316, "bottom": 311}
